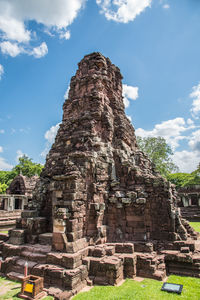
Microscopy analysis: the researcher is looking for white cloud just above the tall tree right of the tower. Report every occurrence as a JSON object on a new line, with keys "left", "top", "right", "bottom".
{"left": 136, "top": 118, "right": 190, "bottom": 150}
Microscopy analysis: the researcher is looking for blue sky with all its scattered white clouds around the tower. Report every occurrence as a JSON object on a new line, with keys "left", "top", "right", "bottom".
{"left": 0, "top": 0, "right": 200, "bottom": 172}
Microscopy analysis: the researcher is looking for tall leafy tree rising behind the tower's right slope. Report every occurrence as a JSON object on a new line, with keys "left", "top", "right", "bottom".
{"left": 137, "top": 136, "right": 178, "bottom": 177}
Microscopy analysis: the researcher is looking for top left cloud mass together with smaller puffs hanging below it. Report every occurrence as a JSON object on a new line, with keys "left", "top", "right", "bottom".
{"left": 0, "top": 0, "right": 86, "bottom": 58}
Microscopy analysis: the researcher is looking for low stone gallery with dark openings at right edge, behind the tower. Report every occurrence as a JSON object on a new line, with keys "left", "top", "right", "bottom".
{"left": 177, "top": 185, "right": 200, "bottom": 221}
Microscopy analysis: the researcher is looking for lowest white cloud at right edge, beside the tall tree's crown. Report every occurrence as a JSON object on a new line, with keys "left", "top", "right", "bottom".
{"left": 172, "top": 150, "right": 200, "bottom": 173}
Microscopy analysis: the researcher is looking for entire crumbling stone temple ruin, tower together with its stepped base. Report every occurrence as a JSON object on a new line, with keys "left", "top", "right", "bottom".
{"left": 0, "top": 53, "right": 200, "bottom": 299}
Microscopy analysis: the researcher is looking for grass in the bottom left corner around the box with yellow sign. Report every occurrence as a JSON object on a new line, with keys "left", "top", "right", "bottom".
{"left": 0, "top": 277, "right": 53, "bottom": 300}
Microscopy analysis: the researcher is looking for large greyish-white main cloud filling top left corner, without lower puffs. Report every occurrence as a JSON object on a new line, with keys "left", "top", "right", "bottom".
{"left": 0, "top": 0, "right": 85, "bottom": 42}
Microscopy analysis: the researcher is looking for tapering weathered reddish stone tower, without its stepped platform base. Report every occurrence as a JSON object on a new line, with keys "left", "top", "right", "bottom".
{"left": 35, "top": 53, "right": 187, "bottom": 252}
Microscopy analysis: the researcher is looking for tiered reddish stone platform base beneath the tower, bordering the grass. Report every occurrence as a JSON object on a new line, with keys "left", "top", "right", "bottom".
{"left": 0, "top": 239, "right": 200, "bottom": 299}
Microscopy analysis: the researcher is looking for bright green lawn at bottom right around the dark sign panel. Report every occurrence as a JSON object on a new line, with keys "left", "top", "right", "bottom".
{"left": 73, "top": 275, "right": 200, "bottom": 300}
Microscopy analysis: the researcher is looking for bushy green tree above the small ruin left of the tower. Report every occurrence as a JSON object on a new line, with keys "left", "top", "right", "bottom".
{"left": 12, "top": 155, "right": 43, "bottom": 177}
